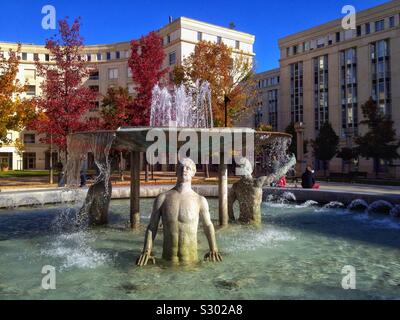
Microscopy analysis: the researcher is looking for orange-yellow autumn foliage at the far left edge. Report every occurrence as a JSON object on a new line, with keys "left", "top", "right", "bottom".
{"left": 0, "top": 46, "right": 35, "bottom": 146}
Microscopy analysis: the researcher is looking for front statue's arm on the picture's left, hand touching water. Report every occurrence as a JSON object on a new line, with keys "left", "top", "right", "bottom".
{"left": 136, "top": 195, "right": 164, "bottom": 267}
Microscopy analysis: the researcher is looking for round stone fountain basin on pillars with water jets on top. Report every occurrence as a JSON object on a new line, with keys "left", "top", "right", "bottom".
{"left": 67, "top": 82, "right": 291, "bottom": 228}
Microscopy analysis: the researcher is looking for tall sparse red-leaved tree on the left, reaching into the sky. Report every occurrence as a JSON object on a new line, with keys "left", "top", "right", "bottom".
{"left": 30, "top": 18, "right": 97, "bottom": 156}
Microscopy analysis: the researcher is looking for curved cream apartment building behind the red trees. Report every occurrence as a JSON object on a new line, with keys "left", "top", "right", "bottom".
{"left": 0, "top": 17, "right": 255, "bottom": 170}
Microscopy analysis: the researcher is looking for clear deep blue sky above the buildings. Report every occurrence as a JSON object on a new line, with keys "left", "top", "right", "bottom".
{"left": 0, "top": 0, "right": 388, "bottom": 72}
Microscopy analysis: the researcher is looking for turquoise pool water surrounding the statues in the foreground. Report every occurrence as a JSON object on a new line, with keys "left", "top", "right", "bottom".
{"left": 0, "top": 199, "right": 400, "bottom": 300}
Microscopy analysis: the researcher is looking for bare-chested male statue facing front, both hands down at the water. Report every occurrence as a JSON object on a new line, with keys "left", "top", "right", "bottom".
{"left": 136, "top": 159, "right": 222, "bottom": 266}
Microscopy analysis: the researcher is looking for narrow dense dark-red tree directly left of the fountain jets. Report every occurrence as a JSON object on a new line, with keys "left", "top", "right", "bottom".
{"left": 129, "top": 32, "right": 167, "bottom": 126}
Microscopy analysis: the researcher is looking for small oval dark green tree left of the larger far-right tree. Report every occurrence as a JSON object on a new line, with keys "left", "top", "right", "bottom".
{"left": 312, "top": 122, "right": 339, "bottom": 176}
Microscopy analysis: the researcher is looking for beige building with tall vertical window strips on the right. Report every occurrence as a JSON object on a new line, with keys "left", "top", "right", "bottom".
{"left": 254, "top": 0, "right": 400, "bottom": 178}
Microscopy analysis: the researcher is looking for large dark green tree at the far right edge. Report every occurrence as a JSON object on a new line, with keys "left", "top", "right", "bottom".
{"left": 355, "top": 98, "right": 400, "bottom": 177}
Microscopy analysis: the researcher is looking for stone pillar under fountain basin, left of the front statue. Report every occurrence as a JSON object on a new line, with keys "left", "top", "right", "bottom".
{"left": 131, "top": 151, "right": 140, "bottom": 229}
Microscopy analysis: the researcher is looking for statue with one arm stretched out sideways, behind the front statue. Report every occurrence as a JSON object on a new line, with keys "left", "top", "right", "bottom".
{"left": 228, "top": 155, "right": 296, "bottom": 224}
